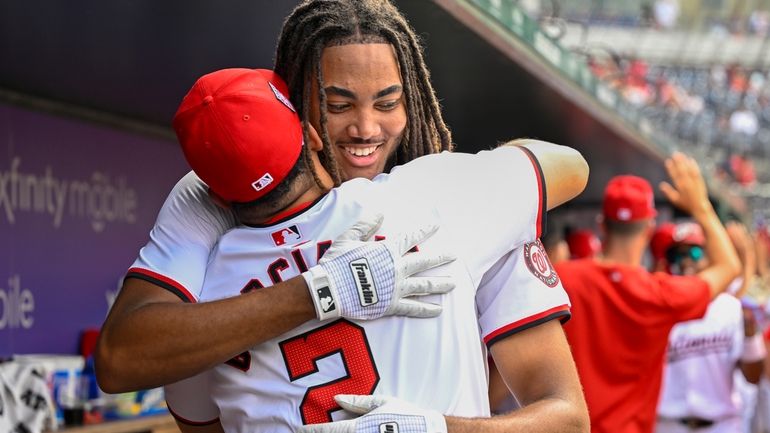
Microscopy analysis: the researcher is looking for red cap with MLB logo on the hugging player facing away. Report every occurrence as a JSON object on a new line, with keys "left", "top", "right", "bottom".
{"left": 173, "top": 68, "right": 303, "bottom": 203}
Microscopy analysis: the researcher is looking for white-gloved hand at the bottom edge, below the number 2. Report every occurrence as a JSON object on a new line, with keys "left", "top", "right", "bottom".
{"left": 297, "top": 395, "right": 447, "bottom": 433}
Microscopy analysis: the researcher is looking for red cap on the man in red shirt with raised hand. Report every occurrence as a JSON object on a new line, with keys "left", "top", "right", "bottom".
{"left": 603, "top": 175, "right": 658, "bottom": 222}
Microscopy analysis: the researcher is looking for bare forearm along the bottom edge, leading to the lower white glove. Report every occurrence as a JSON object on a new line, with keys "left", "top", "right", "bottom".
{"left": 446, "top": 398, "right": 590, "bottom": 433}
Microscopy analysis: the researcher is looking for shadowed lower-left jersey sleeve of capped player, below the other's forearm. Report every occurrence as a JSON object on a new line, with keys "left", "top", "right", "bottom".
{"left": 163, "top": 370, "right": 219, "bottom": 426}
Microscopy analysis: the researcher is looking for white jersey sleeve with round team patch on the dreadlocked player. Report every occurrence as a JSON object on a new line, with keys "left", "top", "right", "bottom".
{"left": 476, "top": 240, "right": 570, "bottom": 347}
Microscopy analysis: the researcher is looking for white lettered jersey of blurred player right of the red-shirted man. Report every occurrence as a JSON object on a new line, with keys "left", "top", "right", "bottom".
{"left": 658, "top": 293, "right": 744, "bottom": 421}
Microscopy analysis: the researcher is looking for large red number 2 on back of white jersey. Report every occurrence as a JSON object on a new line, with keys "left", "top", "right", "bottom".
{"left": 280, "top": 319, "right": 380, "bottom": 424}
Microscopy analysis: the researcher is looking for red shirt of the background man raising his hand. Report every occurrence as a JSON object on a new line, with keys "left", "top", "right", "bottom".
{"left": 556, "top": 259, "right": 711, "bottom": 433}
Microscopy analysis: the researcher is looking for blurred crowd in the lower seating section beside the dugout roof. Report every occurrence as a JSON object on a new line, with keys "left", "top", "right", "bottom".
{"left": 589, "top": 57, "right": 770, "bottom": 187}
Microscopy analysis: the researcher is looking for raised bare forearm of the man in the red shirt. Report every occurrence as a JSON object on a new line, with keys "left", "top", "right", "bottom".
{"left": 693, "top": 203, "right": 741, "bottom": 297}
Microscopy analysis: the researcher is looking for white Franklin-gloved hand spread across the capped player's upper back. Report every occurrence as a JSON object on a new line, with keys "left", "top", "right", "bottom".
{"left": 302, "top": 215, "right": 455, "bottom": 320}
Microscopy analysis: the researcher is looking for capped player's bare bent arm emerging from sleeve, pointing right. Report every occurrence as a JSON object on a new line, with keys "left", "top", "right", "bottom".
{"left": 504, "top": 139, "right": 589, "bottom": 210}
